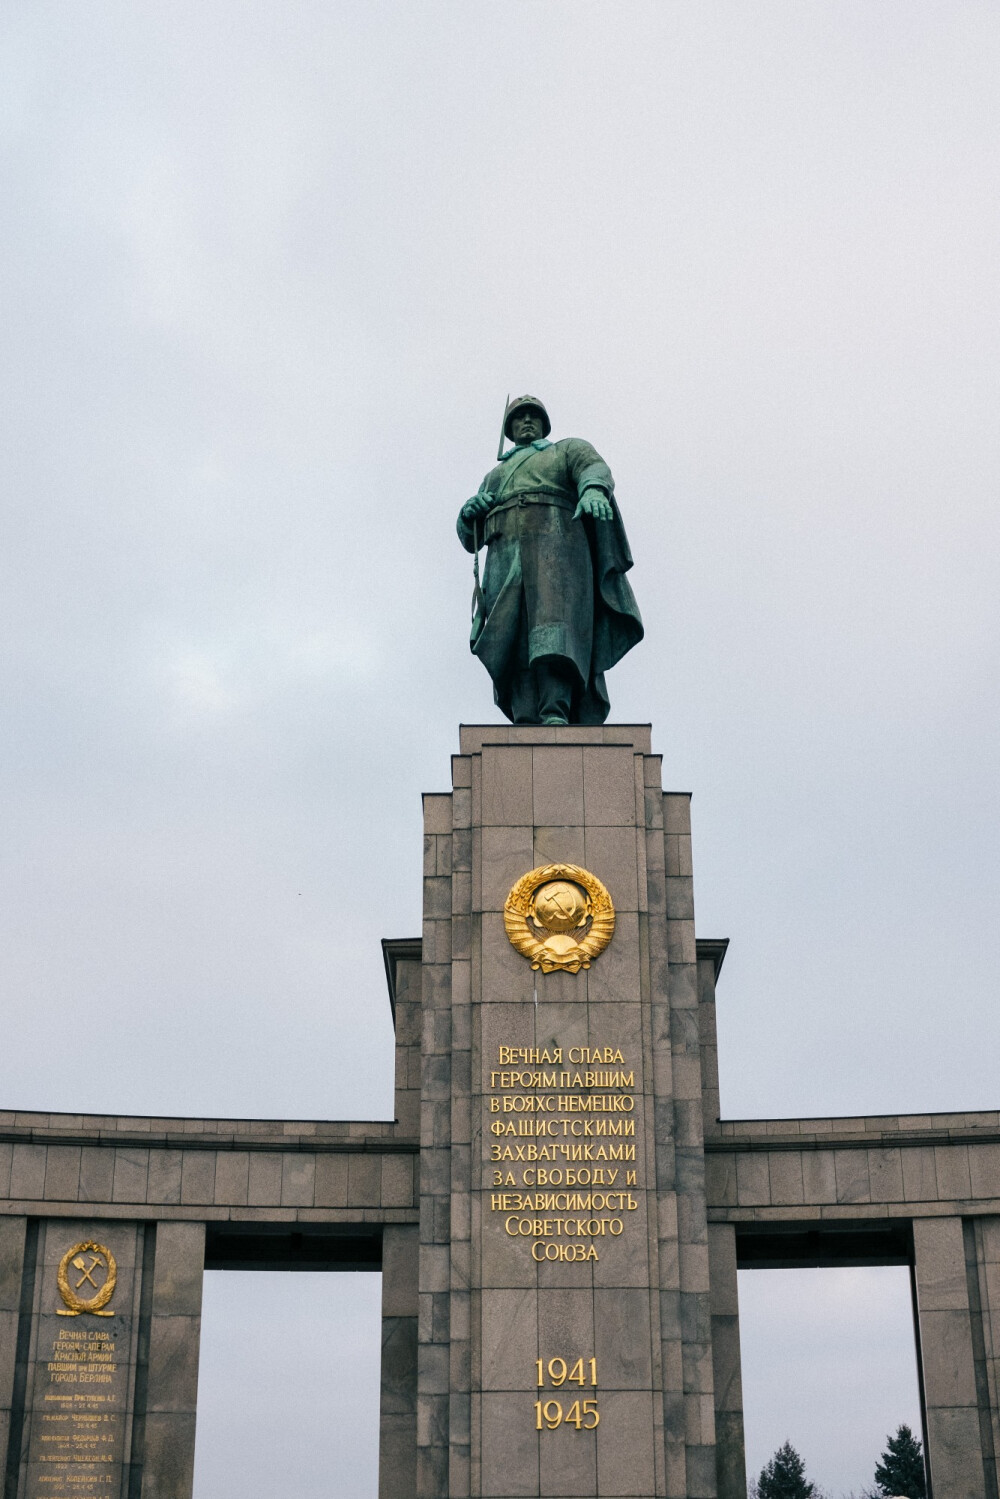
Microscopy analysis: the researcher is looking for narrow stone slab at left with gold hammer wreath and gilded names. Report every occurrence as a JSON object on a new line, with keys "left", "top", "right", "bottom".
{"left": 18, "top": 1220, "right": 141, "bottom": 1499}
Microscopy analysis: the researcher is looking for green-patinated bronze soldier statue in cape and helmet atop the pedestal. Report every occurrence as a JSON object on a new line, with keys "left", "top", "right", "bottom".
{"left": 459, "top": 396, "right": 643, "bottom": 724}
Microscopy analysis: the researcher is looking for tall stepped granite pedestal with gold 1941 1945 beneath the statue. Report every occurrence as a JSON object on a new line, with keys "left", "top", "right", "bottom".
{"left": 407, "top": 726, "right": 715, "bottom": 1499}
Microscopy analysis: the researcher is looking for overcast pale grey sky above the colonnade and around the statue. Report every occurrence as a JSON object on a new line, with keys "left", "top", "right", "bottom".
{"left": 0, "top": 0, "right": 1000, "bottom": 1483}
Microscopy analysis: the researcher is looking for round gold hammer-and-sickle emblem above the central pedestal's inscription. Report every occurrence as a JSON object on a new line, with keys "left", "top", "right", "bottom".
{"left": 504, "top": 863, "right": 615, "bottom": 973}
